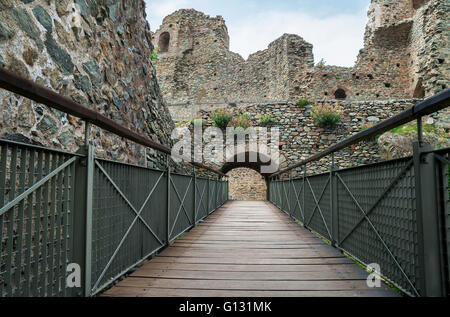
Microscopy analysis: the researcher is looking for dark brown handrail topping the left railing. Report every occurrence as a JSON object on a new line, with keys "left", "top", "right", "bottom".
{"left": 0, "top": 67, "right": 227, "bottom": 177}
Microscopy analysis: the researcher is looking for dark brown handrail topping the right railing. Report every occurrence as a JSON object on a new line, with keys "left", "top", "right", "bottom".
{"left": 269, "top": 88, "right": 450, "bottom": 178}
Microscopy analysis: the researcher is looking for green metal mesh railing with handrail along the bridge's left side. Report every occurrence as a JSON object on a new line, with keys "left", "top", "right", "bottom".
{"left": 0, "top": 68, "right": 228, "bottom": 297}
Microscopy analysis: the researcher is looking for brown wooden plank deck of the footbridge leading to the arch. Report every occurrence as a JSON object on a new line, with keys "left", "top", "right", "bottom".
{"left": 102, "top": 201, "right": 397, "bottom": 297}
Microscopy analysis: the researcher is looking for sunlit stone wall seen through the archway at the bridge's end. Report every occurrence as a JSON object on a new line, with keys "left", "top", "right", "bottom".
{"left": 227, "top": 168, "right": 267, "bottom": 200}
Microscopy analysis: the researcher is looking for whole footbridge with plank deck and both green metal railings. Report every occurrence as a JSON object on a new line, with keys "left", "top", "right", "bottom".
{"left": 0, "top": 68, "right": 450, "bottom": 297}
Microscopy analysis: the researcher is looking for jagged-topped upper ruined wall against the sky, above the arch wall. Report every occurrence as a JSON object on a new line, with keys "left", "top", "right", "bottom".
{"left": 153, "top": 0, "right": 450, "bottom": 104}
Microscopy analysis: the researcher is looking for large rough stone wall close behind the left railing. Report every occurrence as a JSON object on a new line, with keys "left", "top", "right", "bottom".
{"left": 0, "top": 0, "right": 174, "bottom": 167}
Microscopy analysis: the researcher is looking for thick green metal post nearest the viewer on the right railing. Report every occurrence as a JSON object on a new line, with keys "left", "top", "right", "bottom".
{"left": 413, "top": 142, "right": 446, "bottom": 297}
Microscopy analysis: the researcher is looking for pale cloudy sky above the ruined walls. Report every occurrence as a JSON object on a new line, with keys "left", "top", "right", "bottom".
{"left": 146, "top": 0, "right": 370, "bottom": 66}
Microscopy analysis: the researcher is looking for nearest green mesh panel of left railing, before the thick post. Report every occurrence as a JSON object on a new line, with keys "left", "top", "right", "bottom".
{"left": 0, "top": 140, "right": 79, "bottom": 296}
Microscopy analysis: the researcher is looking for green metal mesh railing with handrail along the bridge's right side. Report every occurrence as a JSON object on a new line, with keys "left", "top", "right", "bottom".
{"left": 268, "top": 90, "right": 450, "bottom": 296}
